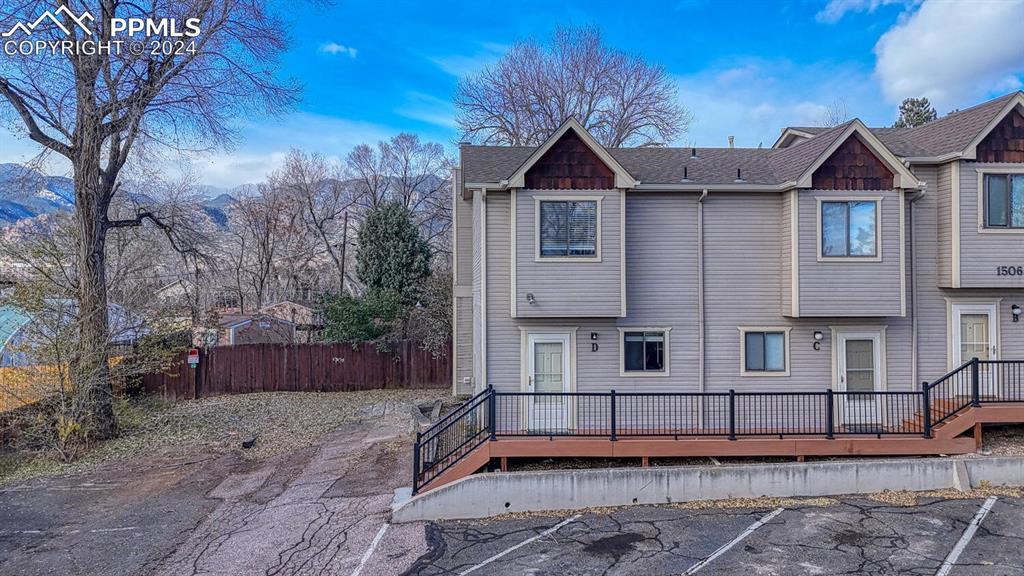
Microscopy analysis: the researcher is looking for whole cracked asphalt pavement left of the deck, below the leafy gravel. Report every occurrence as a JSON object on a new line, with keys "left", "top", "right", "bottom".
{"left": 0, "top": 415, "right": 428, "bottom": 576}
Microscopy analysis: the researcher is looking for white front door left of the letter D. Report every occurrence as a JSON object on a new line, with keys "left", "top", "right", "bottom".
{"left": 526, "top": 334, "right": 571, "bottom": 433}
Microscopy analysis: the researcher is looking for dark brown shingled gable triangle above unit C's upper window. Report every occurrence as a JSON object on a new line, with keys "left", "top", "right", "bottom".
{"left": 811, "top": 135, "right": 893, "bottom": 190}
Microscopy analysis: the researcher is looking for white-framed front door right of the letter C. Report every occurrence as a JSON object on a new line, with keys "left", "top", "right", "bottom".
{"left": 836, "top": 332, "right": 884, "bottom": 427}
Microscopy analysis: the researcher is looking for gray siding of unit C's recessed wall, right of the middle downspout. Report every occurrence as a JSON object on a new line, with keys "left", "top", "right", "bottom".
{"left": 705, "top": 193, "right": 911, "bottom": 392}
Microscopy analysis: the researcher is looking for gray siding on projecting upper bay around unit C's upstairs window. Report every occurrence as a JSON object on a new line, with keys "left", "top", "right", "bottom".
{"left": 794, "top": 190, "right": 902, "bottom": 317}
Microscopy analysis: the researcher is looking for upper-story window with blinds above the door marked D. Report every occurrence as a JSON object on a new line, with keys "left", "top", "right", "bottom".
{"left": 538, "top": 200, "right": 599, "bottom": 258}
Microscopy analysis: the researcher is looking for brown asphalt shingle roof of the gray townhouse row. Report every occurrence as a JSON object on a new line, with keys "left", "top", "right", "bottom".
{"left": 461, "top": 92, "right": 1020, "bottom": 184}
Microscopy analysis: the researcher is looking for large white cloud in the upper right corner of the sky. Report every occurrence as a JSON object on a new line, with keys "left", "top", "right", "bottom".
{"left": 874, "top": 0, "right": 1024, "bottom": 109}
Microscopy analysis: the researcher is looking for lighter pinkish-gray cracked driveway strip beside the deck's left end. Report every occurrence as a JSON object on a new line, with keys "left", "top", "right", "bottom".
{"left": 152, "top": 420, "right": 426, "bottom": 576}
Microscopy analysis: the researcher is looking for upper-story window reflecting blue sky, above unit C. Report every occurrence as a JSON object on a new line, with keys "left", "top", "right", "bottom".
{"left": 820, "top": 200, "right": 879, "bottom": 258}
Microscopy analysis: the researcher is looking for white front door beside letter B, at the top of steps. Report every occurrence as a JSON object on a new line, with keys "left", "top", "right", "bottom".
{"left": 952, "top": 303, "right": 999, "bottom": 396}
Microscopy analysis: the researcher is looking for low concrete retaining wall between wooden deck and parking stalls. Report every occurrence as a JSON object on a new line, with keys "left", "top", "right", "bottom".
{"left": 392, "top": 458, "right": 1024, "bottom": 523}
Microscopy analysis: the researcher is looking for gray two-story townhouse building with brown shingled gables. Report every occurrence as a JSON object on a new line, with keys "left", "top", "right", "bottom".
{"left": 423, "top": 92, "right": 1024, "bottom": 487}
